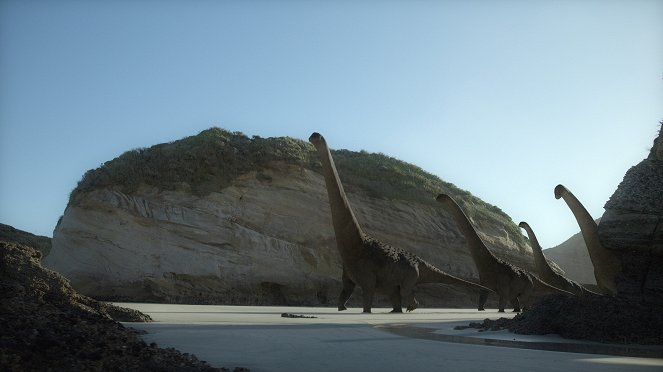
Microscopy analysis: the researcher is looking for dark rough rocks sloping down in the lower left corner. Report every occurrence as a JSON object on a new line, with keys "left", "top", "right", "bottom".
{"left": 0, "top": 241, "right": 248, "bottom": 371}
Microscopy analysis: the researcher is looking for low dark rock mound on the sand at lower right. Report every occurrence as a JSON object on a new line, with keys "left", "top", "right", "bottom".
{"left": 460, "top": 295, "right": 663, "bottom": 345}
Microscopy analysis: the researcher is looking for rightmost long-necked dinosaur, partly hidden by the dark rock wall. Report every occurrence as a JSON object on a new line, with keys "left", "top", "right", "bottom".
{"left": 555, "top": 185, "right": 621, "bottom": 295}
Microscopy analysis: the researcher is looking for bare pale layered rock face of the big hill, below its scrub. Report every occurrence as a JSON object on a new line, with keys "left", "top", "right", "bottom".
{"left": 44, "top": 161, "right": 533, "bottom": 306}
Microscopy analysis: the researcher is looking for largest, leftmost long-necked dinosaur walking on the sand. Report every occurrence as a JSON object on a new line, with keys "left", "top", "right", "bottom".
{"left": 309, "top": 133, "right": 488, "bottom": 313}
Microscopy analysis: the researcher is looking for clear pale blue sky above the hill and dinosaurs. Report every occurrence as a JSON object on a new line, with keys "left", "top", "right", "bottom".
{"left": 0, "top": 0, "right": 663, "bottom": 248}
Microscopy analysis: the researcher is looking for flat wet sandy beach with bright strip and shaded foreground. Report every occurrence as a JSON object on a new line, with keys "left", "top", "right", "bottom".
{"left": 118, "top": 303, "right": 663, "bottom": 372}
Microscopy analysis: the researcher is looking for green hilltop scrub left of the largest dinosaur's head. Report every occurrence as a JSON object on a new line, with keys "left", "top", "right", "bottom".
{"left": 72, "top": 128, "right": 310, "bottom": 199}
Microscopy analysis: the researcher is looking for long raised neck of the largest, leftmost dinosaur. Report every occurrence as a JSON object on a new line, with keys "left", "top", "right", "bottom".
{"left": 317, "top": 144, "right": 363, "bottom": 254}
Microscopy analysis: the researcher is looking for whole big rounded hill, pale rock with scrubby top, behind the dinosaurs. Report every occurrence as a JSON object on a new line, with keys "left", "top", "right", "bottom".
{"left": 45, "top": 128, "right": 532, "bottom": 306}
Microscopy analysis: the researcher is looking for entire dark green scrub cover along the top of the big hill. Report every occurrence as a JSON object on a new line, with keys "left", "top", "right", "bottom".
{"left": 70, "top": 128, "right": 524, "bottom": 243}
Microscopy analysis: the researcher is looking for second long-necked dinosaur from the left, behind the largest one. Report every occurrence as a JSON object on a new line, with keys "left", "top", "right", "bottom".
{"left": 436, "top": 194, "right": 571, "bottom": 312}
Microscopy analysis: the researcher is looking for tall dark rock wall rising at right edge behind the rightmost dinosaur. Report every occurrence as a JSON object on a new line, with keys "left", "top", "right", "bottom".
{"left": 598, "top": 123, "right": 663, "bottom": 302}
